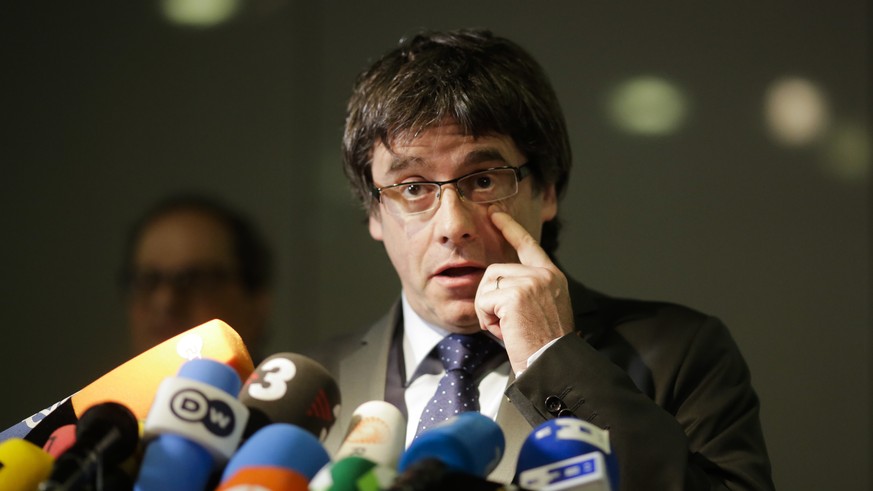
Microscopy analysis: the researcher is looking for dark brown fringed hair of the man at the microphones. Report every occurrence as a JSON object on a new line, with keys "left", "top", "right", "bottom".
{"left": 343, "top": 29, "right": 571, "bottom": 254}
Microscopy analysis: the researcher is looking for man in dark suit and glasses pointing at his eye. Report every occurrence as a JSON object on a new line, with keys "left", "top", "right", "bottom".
{"left": 313, "top": 31, "right": 773, "bottom": 490}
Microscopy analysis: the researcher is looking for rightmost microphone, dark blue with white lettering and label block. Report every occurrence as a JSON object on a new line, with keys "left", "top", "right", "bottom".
{"left": 514, "top": 417, "right": 618, "bottom": 491}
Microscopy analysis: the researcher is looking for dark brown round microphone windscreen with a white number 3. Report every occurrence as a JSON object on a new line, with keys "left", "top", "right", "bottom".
{"left": 239, "top": 353, "right": 340, "bottom": 442}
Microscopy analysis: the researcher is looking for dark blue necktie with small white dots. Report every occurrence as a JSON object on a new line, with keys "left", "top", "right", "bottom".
{"left": 415, "top": 333, "right": 503, "bottom": 437}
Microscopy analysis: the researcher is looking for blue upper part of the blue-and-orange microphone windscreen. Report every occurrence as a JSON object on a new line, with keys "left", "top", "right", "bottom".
{"left": 221, "top": 423, "right": 330, "bottom": 484}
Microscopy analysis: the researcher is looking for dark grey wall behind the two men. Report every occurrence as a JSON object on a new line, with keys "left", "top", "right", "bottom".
{"left": 0, "top": 0, "right": 873, "bottom": 490}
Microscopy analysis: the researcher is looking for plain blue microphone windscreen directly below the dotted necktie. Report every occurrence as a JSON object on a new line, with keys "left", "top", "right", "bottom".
{"left": 398, "top": 411, "right": 506, "bottom": 477}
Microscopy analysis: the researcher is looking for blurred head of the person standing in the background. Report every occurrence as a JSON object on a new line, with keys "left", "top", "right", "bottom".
{"left": 121, "top": 194, "right": 272, "bottom": 363}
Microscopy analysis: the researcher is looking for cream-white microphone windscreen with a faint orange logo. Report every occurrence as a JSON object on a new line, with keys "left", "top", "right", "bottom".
{"left": 334, "top": 401, "right": 406, "bottom": 468}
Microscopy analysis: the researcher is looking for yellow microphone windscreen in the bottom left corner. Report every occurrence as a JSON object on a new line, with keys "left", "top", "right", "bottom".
{"left": 0, "top": 438, "right": 54, "bottom": 491}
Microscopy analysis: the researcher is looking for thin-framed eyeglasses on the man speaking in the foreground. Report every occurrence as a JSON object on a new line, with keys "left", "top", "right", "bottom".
{"left": 372, "top": 162, "right": 531, "bottom": 216}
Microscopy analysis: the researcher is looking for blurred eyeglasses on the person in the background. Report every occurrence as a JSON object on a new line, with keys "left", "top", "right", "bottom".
{"left": 122, "top": 267, "right": 236, "bottom": 297}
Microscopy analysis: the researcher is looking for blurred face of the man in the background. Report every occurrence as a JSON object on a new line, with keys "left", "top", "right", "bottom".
{"left": 128, "top": 210, "right": 267, "bottom": 353}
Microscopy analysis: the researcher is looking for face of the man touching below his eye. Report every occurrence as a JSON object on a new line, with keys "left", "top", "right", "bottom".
{"left": 370, "top": 124, "right": 557, "bottom": 333}
